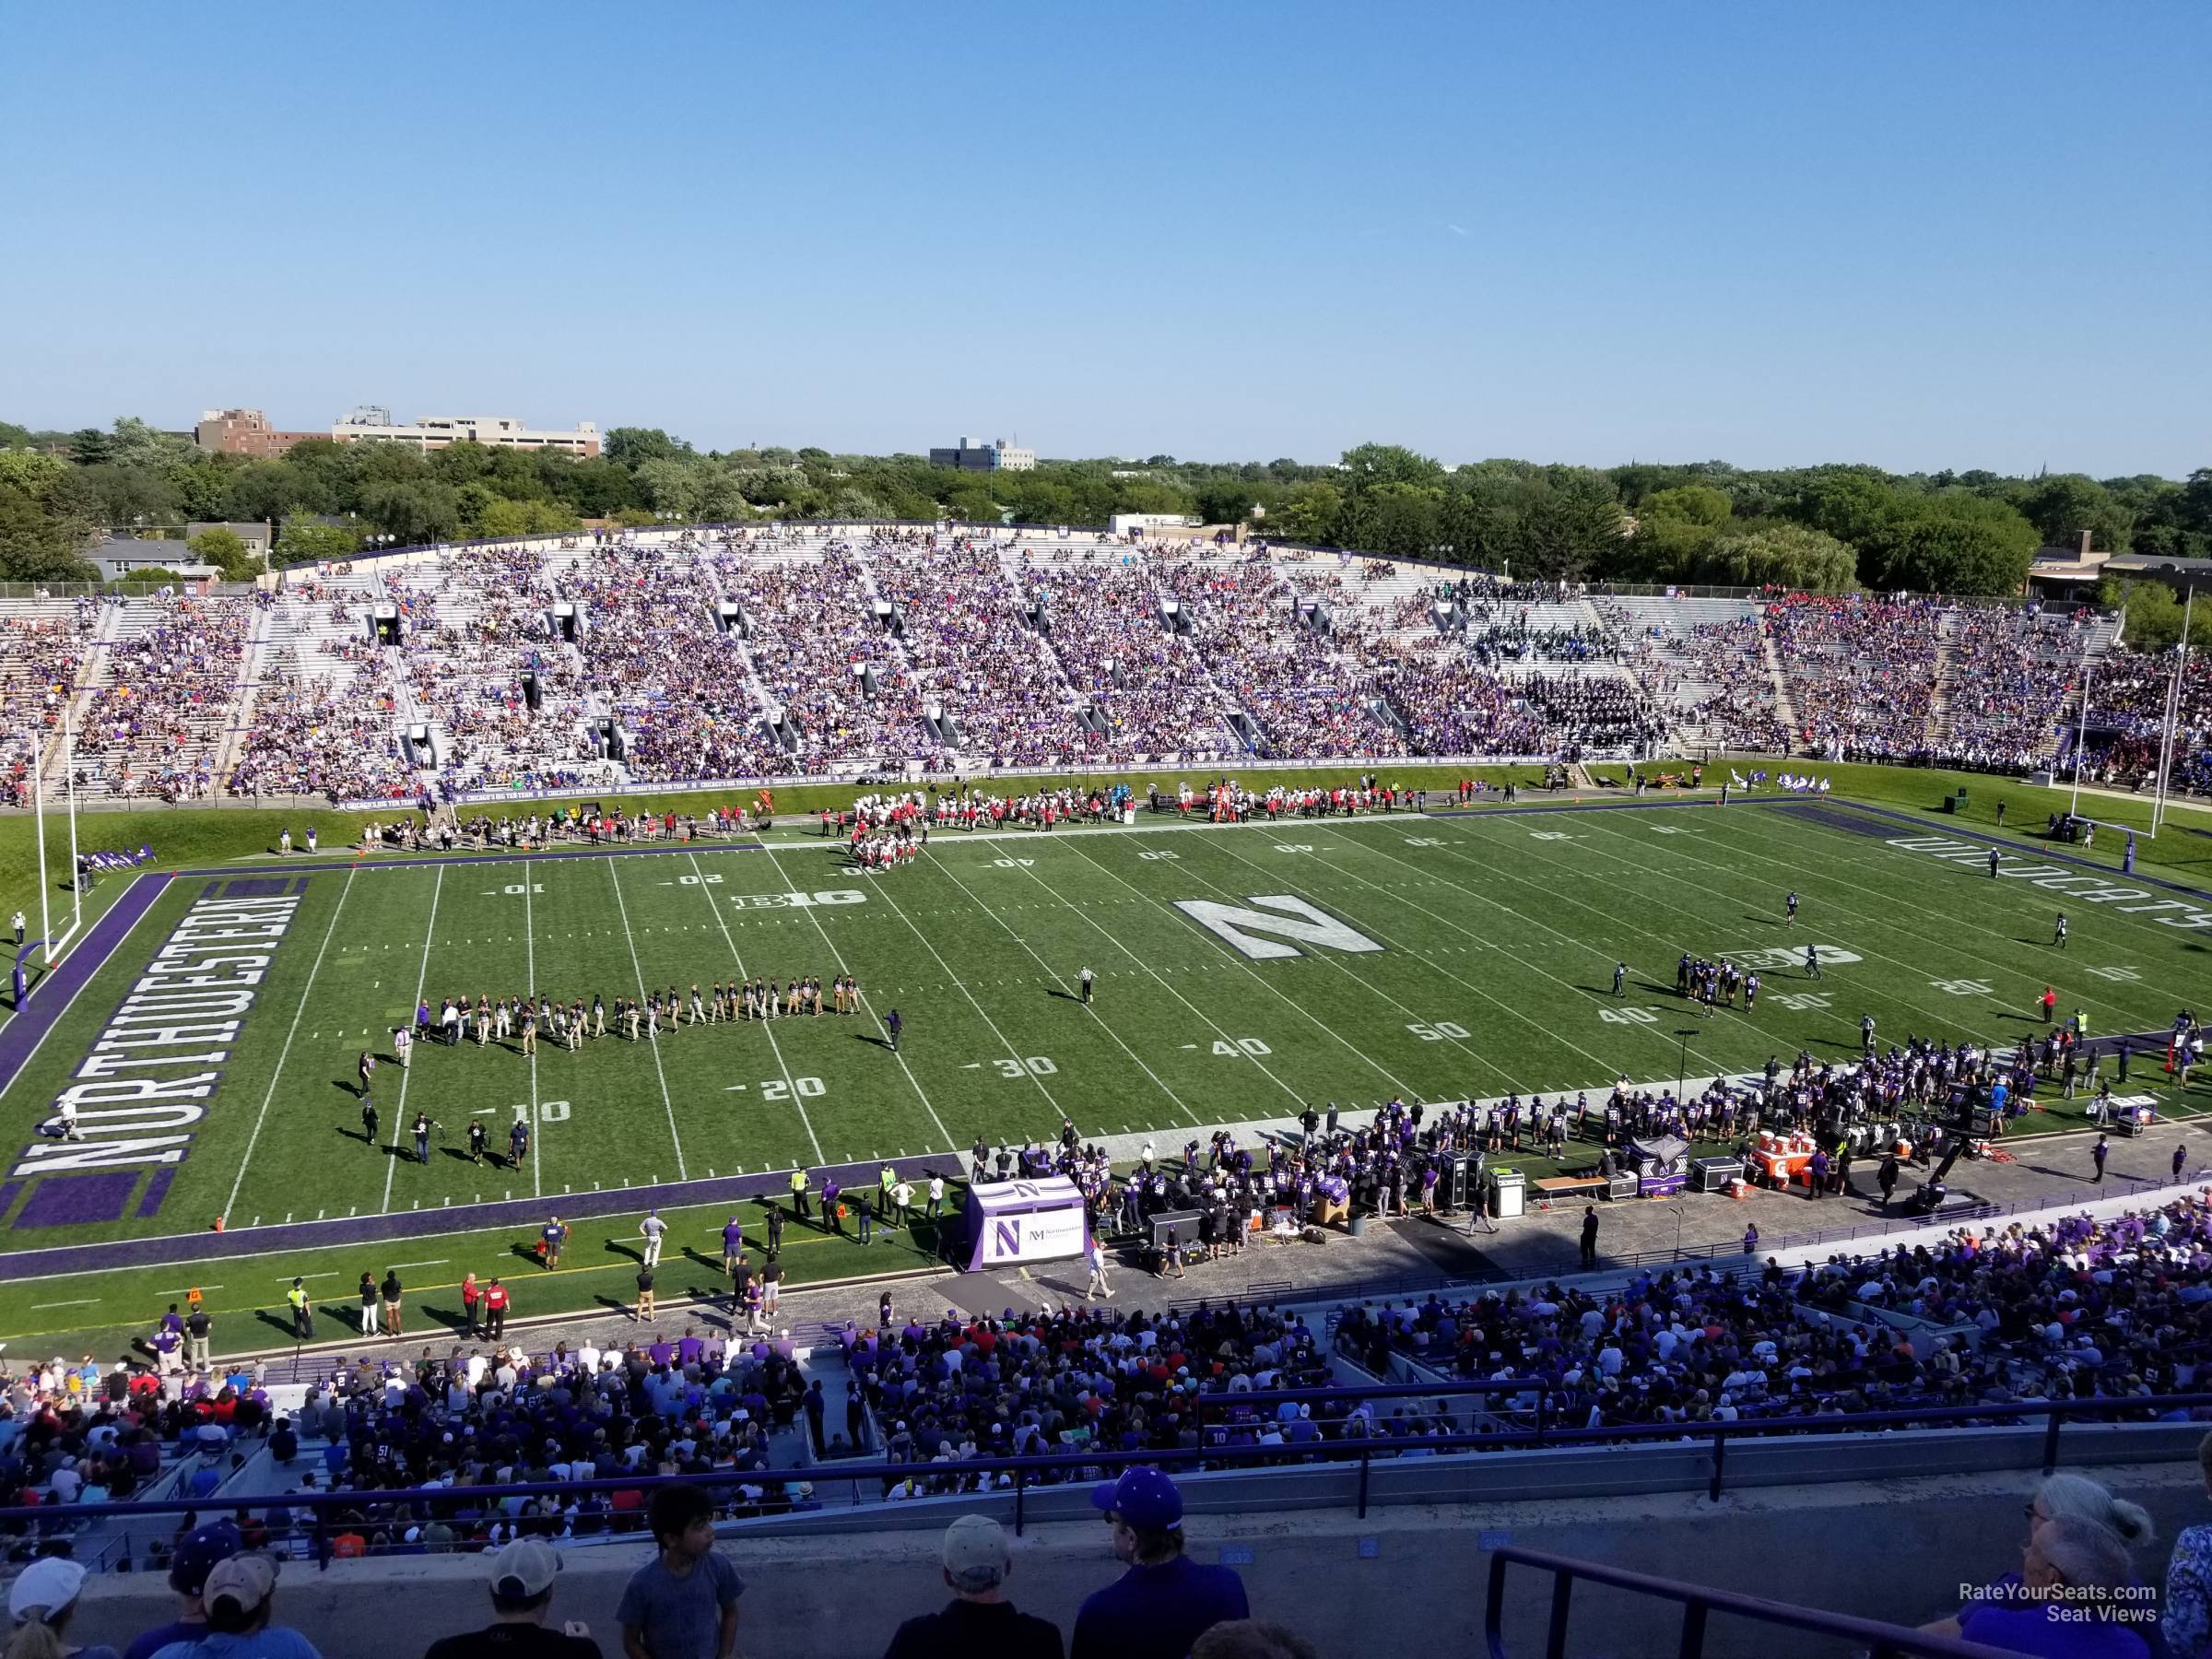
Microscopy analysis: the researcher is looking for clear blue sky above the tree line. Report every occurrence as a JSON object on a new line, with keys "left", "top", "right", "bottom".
{"left": 0, "top": 0, "right": 2212, "bottom": 476}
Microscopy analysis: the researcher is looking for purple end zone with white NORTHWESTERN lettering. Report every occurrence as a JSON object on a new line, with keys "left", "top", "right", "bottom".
{"left": 0, "top": 878, "right": 308, "bottom": 1228}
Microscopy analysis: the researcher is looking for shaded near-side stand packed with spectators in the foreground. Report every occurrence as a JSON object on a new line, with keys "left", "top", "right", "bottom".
{"left": 13, "top": 1185, "right": 2212, "bottom": 1654}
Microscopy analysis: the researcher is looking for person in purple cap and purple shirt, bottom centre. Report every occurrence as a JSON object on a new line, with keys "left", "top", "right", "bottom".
{"left": 1068, "top": 1469, "right": 1252, "bottom": 1659}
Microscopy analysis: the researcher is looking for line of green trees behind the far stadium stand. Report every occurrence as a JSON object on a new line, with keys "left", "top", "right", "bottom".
{"left": 0, "top": 416, "right": 2212, "bottom": 593}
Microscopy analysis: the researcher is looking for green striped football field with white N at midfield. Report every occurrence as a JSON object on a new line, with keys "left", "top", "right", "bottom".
{"left": 0, "top": 801, "right": 2212, "bottom": 1362}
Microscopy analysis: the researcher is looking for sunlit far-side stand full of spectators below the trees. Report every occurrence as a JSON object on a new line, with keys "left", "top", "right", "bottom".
{"left": 0, "top": 524, "right": 2212, "bottom": 803}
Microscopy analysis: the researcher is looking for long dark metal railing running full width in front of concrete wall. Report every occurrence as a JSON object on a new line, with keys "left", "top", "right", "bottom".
{"left": 0, "top": 1378, "right": 2212, "bottom": 1588}
